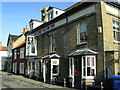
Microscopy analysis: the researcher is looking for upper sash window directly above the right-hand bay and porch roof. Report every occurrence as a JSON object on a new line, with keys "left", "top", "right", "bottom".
{"left": 78, "top": 22, "right": 87, "bottom": 44}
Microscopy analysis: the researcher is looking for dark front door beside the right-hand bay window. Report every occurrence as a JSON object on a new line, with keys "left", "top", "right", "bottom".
{"left": 74, "top": 57, "right": 82, "bottom": 88}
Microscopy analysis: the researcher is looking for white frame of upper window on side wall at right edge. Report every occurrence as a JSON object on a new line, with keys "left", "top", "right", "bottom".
{"left": 113, "top": 19, "right": 120, "bottom": 43}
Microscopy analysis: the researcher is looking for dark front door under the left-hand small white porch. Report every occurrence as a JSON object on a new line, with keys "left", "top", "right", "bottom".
{"left": 45, "top": 60, "right": 51, "bottom": 83}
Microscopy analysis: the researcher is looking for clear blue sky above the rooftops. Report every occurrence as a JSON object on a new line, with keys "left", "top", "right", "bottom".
{"left": 0, "top": 2, "right": 77, "bottom": 46}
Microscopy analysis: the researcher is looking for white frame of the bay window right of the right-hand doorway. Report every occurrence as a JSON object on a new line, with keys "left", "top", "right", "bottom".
{"left": 82, "top": 55, "right": 96, "bottom": 79}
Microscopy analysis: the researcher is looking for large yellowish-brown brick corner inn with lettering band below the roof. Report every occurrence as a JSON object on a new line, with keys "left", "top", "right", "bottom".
{"left": 24, "top": 1, "right": 120, "bottom": 88}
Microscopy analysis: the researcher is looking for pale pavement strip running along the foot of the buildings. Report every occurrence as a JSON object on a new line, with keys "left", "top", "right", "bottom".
{"left": 2, "top": 71, "right": 75, "bottom": 90}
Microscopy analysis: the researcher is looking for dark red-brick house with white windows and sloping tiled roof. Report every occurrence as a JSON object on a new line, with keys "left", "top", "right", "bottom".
{"left": 12, "top": 26, "right": 28, "bottom": 75}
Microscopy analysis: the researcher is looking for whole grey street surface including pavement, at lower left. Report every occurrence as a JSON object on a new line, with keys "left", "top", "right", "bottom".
{"left": 0, "top": 72, "right": 76, "bottom": 90}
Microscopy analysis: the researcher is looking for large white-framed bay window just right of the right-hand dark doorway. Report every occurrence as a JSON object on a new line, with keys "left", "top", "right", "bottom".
{"left": 82, "top": 56, "right": 96, "bottom": 78}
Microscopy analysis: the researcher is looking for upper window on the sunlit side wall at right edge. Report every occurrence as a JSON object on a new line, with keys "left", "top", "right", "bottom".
{"left": 113, "top": 20, "right": 120, "bottom": 42}
